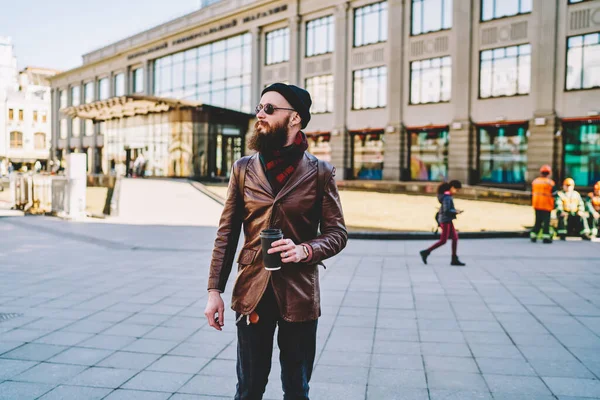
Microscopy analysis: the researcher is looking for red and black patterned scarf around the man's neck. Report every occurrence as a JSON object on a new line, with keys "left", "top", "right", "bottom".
{"left": 260, "top": 131, "right": 308, "bottom": 194}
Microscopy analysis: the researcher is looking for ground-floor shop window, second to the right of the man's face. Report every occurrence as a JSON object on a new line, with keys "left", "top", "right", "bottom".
{"left": 350, "top": 131, "right": 383, "bottom": 180}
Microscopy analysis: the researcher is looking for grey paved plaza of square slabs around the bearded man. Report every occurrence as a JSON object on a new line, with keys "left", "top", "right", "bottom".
{"left": 0, "top": 217, "right": 600, "bottom": 400}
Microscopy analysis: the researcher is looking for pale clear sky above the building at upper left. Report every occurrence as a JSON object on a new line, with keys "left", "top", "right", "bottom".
{"left": 0, "top": 0, "right": 200, "bottom": 71}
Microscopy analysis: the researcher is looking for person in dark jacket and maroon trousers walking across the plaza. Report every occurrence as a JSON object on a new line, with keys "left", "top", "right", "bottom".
{"left": 420, "top": 180, "right": 466, "bottom": 267}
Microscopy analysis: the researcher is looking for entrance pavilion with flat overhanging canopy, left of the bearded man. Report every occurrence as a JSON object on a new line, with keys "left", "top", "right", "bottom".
{"left": 61, "top": 95, "right": 254, "bottom": 180}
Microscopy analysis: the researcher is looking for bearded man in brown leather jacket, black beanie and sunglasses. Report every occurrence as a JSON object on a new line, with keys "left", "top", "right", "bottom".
{"left": 204, "top": 83, "right": 347, "bottom": 400}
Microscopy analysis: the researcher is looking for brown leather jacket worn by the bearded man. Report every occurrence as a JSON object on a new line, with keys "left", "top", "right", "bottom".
{"left": 208, "top": 153, "right": 348, "bottom": 322}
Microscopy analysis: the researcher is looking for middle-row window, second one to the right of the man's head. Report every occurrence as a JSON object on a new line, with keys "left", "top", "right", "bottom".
{"left": 352, "top": 67, "right": 387, "bottom": 110}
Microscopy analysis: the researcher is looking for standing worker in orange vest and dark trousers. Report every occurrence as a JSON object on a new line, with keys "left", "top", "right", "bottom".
{"left": 529, "top": 165, "right": 556, "bottom": 243}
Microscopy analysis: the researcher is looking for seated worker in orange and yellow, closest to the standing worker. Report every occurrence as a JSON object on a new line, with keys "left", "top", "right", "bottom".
{"left": 556, "top": 178, "right": 591, "bottom": 240}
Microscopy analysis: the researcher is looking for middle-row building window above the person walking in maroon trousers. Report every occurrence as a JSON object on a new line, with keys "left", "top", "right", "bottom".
{"left": 410, "top": 57, "right": 452, "bottom": 104}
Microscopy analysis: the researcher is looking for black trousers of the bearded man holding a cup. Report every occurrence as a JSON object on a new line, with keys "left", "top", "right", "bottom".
{"left": 235, "top": 284, "right": 317, "bottom": 400}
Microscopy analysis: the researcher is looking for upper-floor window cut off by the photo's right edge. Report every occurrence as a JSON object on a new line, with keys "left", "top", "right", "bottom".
{"left": 566, "top": 32, "right": 600, "bottom": 90}
